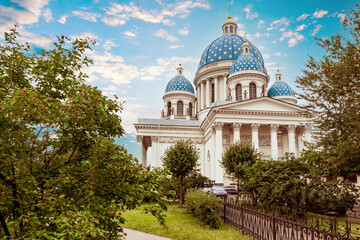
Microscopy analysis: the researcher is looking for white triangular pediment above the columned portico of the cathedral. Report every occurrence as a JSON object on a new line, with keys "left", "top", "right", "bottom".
{"left": 214, "top": 97, "right": 304, "bottom": 112}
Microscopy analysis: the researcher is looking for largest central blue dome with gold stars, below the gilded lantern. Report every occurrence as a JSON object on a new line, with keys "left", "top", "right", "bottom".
{"left": 198, "top": 35, "right": 264, "bottom": 68}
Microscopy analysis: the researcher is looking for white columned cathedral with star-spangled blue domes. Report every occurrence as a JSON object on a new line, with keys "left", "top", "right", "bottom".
{"left": 134, "top": 16, "right": 312, "bottom": 184}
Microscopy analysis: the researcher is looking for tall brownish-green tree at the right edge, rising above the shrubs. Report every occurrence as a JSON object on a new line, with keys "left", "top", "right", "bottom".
{"left": 296, "top": 5, "right": 360, "bottom": 175}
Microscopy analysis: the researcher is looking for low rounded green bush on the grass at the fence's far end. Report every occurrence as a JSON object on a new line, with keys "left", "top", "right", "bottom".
{"left": 185, "top": 190, "right": 222, "bottom": 229}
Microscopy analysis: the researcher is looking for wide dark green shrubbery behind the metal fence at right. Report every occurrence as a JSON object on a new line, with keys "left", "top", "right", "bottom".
{"left": 243, "top": 155, "right": 359, "bottom": 216}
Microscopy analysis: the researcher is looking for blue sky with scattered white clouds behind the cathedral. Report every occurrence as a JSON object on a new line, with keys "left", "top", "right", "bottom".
{"left": 0, "top": 0, "right": 358, "bottom": 161}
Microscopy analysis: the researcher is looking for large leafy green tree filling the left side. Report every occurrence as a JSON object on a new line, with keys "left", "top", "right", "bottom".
{"left": 0, "top": 28, "right": 167, "bottom": 239}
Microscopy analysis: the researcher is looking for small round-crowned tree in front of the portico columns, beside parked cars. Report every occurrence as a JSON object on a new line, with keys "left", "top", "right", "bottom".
{"left": 221, "top": 142, "right": 260, "bottom": 189}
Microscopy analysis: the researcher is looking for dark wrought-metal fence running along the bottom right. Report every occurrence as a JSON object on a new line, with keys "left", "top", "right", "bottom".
{"left": 220, "top": 200, "right": 360, "bottom": 240}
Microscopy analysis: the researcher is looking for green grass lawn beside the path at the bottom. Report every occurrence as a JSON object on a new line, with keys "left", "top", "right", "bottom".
{"left": 123, "top": 205, "right": 251, "bottom": 240}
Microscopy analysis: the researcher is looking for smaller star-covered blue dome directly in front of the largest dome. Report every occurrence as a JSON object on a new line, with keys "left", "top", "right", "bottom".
{"left": 229, "top": 54, "right": 265, "bottom": 76}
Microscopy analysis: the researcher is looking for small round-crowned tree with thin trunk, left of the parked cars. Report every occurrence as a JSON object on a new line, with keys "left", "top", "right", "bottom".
{"left": 162, "top": 140, "right": 200, "bottom": 208}
